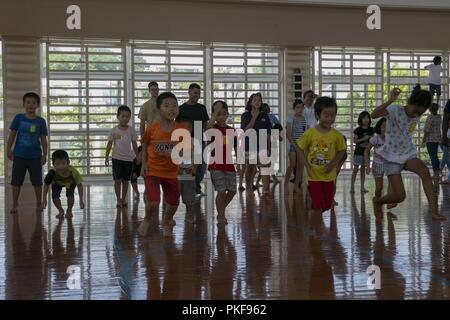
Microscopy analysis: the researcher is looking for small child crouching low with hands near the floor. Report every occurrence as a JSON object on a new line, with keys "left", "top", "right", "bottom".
{"left": 42, "top": 150, "right": 84, "bottom": 219}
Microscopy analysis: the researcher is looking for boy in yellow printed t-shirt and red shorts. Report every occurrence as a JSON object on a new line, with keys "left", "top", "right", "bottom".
{"left": 297, "top": 97, "right": 346, "bottom": 215}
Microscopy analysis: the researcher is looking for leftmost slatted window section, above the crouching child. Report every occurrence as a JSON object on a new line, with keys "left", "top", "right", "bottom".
{"left": 46, "top": 41, "right": 126, "bottom": 175}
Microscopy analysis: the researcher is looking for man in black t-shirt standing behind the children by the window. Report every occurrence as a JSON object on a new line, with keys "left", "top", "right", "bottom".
{"left": 177, "top": 83, "right": 209, "bottom": 197}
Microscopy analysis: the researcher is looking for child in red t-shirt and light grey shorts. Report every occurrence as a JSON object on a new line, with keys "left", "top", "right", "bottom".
{"left": 208, "top": 100, "right": 237, "bottom": 224}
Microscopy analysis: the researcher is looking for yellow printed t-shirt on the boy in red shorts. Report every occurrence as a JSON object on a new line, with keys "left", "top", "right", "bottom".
{"left": 297, "top": 128, "right": 346, "bottom": 181}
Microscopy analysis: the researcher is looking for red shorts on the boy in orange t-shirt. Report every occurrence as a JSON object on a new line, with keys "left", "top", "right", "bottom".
{"left": 144, "top": 176, "right": 180, "bottom": 207}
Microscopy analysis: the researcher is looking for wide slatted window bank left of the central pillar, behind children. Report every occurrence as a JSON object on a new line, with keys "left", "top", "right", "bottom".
{"left": 43, "top": 40, "right": 281, "bottom": 175}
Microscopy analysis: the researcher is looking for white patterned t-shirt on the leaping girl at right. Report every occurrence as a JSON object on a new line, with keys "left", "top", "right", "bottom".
{"left": 379, "top": 105, "right": 419, "bottom": 164}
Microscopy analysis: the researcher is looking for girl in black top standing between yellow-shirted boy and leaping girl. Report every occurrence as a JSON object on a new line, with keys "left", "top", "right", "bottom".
{"left": 350, "top": 111, "right": 374, "bottom": 193}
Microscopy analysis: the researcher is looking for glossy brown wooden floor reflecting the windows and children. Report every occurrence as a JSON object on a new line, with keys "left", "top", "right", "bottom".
{"left": 0, "top": 175, "right": 450, "bottom": 299}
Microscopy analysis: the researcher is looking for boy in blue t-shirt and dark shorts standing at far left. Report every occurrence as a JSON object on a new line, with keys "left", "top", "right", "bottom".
{"left": 6, "top": 92, "right": 47, "bottom": 213}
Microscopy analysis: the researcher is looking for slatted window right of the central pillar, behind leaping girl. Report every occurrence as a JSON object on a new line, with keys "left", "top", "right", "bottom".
{"left": 314, "top": 47, "right": 448, "bottom": 168}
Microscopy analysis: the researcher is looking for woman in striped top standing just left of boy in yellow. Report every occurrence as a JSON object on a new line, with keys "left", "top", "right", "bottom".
{"left": 285, "top": 100, "right": 306, "bottom": 192}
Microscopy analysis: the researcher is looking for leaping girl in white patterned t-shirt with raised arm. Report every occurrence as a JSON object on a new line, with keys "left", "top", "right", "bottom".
{"left": 372, "top": 86, "right": 445, "bottom": 219}
